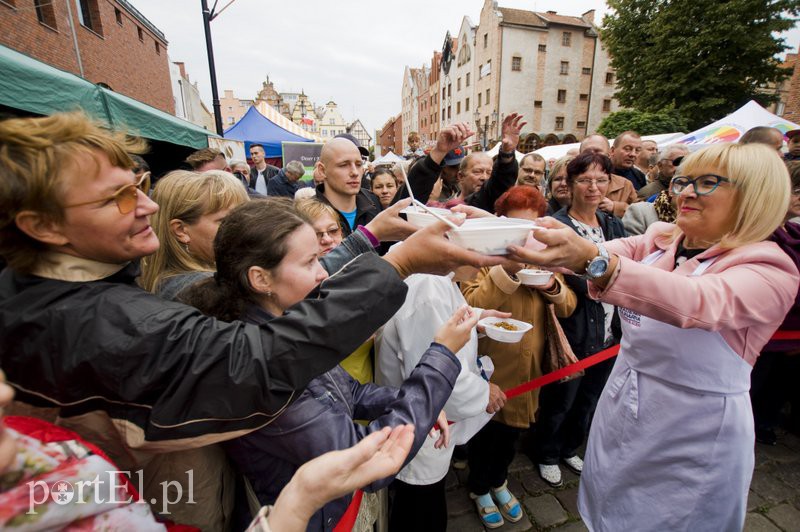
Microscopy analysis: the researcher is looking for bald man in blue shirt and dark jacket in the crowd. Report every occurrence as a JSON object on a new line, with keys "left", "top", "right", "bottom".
{"left": 317, "top": 138, "right": 382, "bottom": 236}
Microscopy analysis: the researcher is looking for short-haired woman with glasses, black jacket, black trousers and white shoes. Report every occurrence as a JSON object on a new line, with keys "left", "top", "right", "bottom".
{"left": 533, "top": 152, "right": 626, "bottom": 486}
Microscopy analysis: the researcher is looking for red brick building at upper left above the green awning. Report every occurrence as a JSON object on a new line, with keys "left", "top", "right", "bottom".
{"left": 0, "top": 0, "right": 175, "bottom": 114}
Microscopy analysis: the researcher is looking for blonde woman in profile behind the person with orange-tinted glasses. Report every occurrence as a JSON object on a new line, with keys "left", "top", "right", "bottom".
{"left": 140, "top": 170, "right": 248, "bottom": 300}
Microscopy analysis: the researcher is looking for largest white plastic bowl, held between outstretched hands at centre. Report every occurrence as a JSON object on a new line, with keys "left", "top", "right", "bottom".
{"left": 447, "top": 218, "right": 536, "bottom": 255}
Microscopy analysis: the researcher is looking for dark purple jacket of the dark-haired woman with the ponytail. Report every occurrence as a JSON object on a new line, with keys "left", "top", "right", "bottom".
{"left": 225, "top": 307, "right": 461, "bottom": 531}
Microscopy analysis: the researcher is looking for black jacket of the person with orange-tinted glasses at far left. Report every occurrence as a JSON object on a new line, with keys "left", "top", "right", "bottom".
{"left": 0, "top": 253, "right": 407, "bottom": 444}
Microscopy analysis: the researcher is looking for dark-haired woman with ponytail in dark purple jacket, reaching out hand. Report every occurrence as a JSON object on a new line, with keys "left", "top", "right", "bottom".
{"left": 186, "top": 199, "right": 477, "bottom": 530}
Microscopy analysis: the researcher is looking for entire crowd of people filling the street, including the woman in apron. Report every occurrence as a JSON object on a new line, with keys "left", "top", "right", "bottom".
{"left": 0, "top": 109, "right": 800, "bottom": 531}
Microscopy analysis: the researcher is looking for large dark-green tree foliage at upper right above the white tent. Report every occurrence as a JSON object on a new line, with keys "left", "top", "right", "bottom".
{"left": 601, "top": 0, "right": 800, "bottom": 129}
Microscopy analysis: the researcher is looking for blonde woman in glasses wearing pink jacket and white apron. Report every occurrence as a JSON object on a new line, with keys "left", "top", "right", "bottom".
{"left": 511, "top": 144, "right": 800, "bottom": 531}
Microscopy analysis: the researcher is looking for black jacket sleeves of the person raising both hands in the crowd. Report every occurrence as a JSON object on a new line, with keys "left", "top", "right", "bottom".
{"left": 393, "top": 155, "right": 519, "bottom": 213}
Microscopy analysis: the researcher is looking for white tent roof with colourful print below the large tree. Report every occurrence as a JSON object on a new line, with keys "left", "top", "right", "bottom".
{"left": 673, "top": 100, "right": 800, "bottom": 151}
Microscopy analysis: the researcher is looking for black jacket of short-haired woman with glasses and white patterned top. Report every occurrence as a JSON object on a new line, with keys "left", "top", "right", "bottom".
{"left": 553, "top": 207, "right": 626, "bottom": 359}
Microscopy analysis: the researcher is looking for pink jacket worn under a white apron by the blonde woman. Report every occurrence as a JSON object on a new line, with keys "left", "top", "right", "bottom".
{"left": 589, "top": 222, "right": 800, "bottom": 365}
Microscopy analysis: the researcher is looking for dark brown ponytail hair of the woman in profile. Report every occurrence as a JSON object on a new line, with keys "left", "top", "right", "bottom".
{"left": 181, "top": 198, "right": 306, "bottom": 321}
